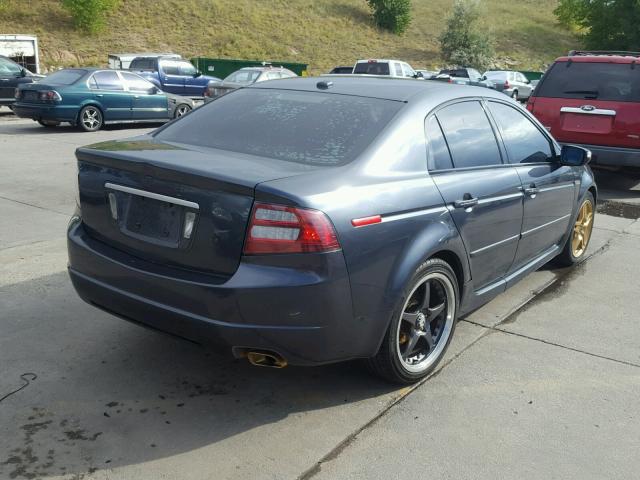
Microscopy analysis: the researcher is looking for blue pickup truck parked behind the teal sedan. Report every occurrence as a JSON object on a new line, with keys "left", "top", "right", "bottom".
{"left": 129, "top": 57, "right": 220, "bottom": 97}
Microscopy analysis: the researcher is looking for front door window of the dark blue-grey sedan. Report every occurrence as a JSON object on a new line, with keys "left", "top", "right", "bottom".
{"left": 489, "top": 102, "right": 553, "bottom": 163}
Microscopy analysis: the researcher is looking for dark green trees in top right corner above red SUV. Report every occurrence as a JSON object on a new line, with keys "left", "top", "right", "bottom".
{"left": 555, "top": 0, "right": 640, "bottom": 51}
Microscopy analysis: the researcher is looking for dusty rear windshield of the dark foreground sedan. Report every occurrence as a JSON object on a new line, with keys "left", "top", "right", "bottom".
{"left": 156, "top": 88, "right": 403, "bottom": 166}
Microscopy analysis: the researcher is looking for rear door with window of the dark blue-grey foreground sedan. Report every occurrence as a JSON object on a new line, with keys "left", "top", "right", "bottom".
{"left": 427, "top": 100, "right": 522, "bottom": 290}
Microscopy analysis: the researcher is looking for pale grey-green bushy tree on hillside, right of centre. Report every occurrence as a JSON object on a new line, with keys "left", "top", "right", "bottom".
{"left": 440, "top": 0, "right": 494, "bottom": 70}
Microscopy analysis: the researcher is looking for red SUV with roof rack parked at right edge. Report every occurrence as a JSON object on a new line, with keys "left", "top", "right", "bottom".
{"left": 527, "top": 51, "right": 640, "bottom": 167}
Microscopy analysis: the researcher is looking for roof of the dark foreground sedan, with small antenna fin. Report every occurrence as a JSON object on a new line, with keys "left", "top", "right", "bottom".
{"left": 248, "top": 74, "right": 504, "bottom": 102}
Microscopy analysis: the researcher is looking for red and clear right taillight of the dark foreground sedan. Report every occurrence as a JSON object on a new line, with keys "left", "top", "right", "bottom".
{"left": 244, "top": 203, "right": 340, "bottom": 255}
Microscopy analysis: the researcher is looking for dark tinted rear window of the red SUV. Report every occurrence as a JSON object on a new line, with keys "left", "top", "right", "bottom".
{"left": 536, "top": 62, "right": 640, "bottom": 102}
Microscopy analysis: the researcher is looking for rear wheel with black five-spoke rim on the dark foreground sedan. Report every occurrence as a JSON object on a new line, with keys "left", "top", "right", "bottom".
{"left": 368, "top": 258, "right": 460, "bottom": 385}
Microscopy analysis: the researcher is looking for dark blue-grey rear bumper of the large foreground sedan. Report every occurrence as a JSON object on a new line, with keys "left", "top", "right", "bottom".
{"left": 68, "top": 222, "right": 364, "bottom": 365}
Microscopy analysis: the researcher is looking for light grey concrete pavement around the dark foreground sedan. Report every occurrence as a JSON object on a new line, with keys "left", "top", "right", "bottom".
{"left": 0, "top": 114, "right": 640, "bottom": 480}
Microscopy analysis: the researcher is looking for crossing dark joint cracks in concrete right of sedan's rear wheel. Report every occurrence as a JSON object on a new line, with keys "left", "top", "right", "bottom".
{"left": 297, "top": 232, "right": 620, "bottom": 480}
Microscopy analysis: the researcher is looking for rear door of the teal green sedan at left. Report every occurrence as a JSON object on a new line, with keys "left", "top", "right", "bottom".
{"left": 87, "top": 70, "right": 133, "bottom": 122}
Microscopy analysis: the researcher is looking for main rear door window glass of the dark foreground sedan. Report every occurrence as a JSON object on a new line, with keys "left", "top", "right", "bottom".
{"left": 436, "top": 101, "right": 502, "bottom": 168}
